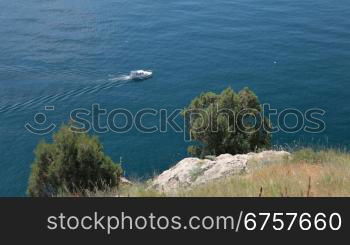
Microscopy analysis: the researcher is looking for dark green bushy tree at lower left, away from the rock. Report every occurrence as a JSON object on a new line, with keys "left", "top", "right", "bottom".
{"left": 27, "top": 126, "right": 122, "bottom": 197}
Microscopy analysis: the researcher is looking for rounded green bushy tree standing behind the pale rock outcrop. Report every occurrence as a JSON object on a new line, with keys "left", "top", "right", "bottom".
{"left": 182, "top": 88, "right": 271, "bottom": 157}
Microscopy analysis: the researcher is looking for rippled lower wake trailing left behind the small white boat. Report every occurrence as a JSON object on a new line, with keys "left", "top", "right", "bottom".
{"left": 0, "top": 75, "right": 132, "bottom": 114}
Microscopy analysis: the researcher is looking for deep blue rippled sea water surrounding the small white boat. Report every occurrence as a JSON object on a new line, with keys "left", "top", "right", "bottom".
{"left": 0, "top": 0, "right": 350, "bottom": 196}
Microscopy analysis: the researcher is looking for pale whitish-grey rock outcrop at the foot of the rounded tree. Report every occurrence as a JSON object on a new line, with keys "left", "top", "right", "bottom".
{"left": 151, "top": 151, "right": 290, "bottom": 192}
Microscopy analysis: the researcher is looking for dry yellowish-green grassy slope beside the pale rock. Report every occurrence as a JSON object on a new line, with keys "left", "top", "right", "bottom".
{"left": 117, "top": 149, "right": 350, "bottom": 197}
